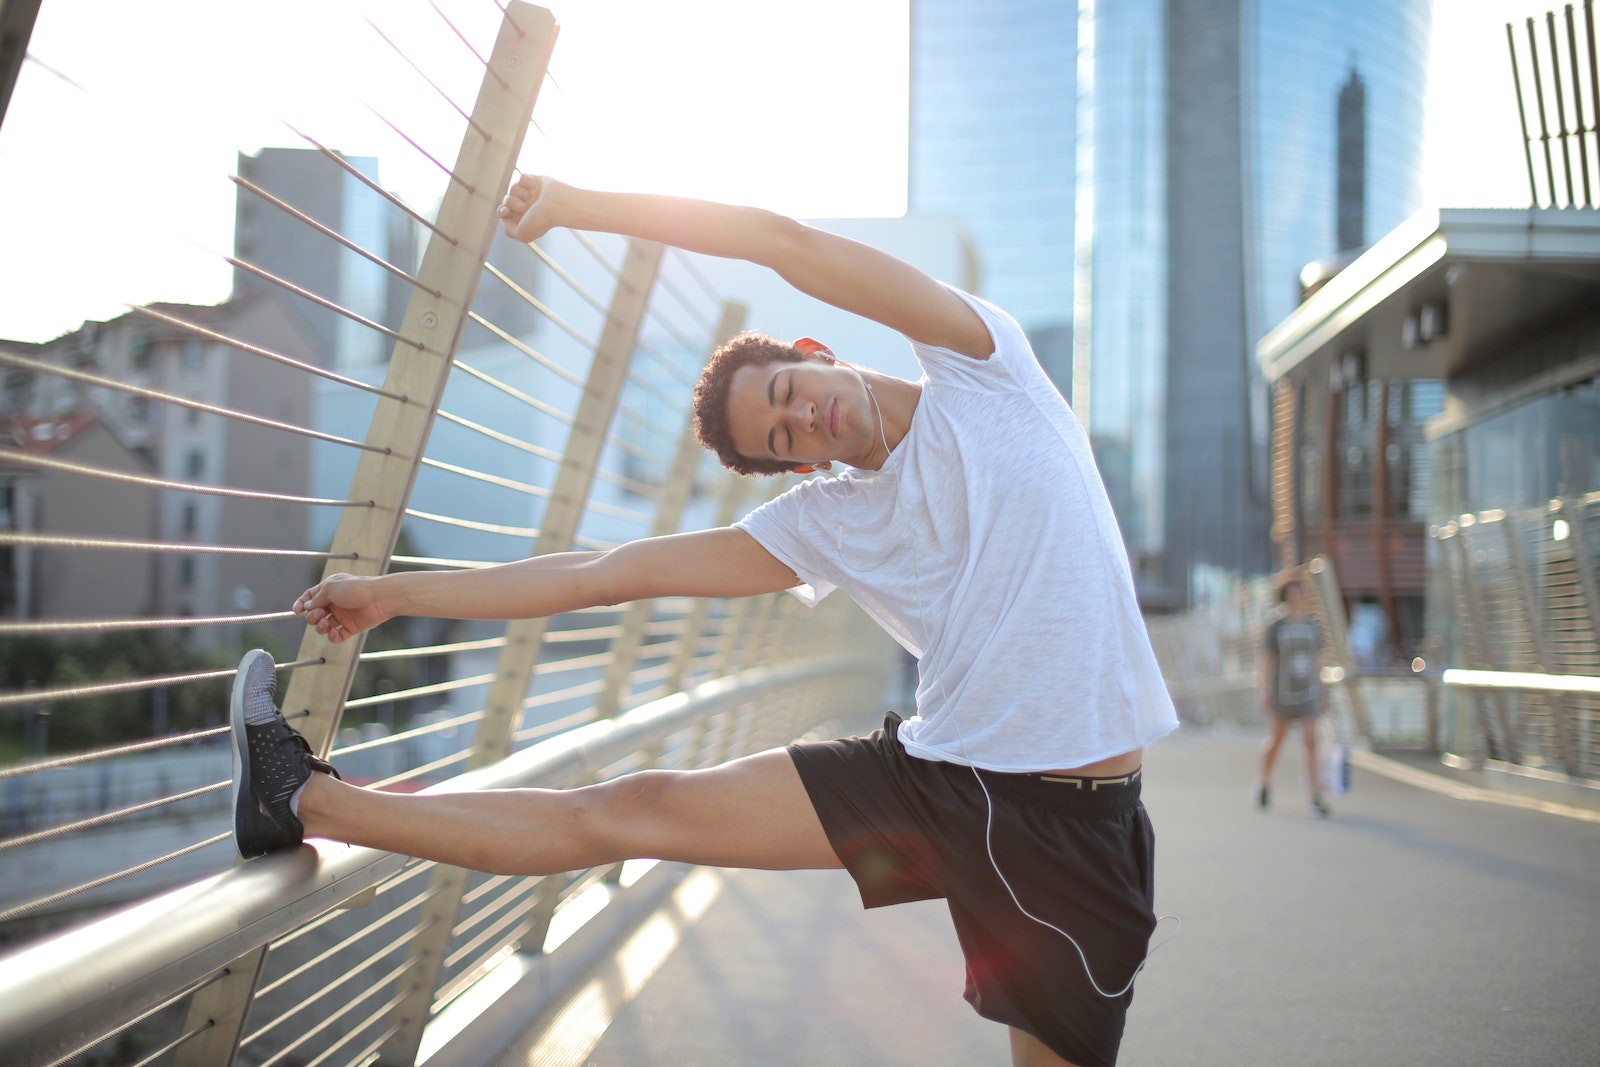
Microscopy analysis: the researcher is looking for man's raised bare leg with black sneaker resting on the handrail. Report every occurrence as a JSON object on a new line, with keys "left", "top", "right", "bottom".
{"left": 229, "top": 649, "right": 840, "bottom": 873}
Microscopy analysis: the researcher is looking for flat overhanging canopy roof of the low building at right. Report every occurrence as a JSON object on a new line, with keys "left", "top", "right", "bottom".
{"left": 1256, "top": 208, "right": 1600, "bottom": 381}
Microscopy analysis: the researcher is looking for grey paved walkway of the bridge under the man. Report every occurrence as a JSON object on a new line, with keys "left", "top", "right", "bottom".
{"left": 517, "top": 729, "right": 1600, "bottom": 1067}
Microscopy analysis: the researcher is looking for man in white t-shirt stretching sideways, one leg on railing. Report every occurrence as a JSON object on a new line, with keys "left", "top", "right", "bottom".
{"left": 234, "top": 178, "right": 1178, "bottom": 1067}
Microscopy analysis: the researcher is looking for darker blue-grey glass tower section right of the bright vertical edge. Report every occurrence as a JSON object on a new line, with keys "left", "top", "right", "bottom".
{"left": 1074, "top": 0, "right": 1430, "bottom": 608}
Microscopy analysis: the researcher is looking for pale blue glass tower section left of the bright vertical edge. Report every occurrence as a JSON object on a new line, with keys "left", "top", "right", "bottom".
{"left": 907, "top": 0, "right": 1077, "bottom": 395}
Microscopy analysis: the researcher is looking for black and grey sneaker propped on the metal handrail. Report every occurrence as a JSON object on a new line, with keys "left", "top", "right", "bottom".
{"left": 229, "top": 648, "right": 339, "bottom": 859}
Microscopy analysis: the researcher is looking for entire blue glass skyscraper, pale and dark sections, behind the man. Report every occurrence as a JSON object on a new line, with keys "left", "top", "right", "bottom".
{"left": 910, "top": 0, "right": 1430, "bottom": 608}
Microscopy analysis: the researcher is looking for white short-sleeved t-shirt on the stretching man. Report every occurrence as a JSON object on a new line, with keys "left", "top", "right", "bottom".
{"left": 736, "top": 290, "right": 1178, "bottom": 771}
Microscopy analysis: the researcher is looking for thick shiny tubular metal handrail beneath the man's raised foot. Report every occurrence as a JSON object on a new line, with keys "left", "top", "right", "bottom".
{"left": 0, "top": 656, "right": 882, "bottom": 1067}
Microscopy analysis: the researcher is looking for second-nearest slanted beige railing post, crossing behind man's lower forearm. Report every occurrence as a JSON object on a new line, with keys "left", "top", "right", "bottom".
{"left": 378, "top": 240, "right": 664, "bottom": 1065}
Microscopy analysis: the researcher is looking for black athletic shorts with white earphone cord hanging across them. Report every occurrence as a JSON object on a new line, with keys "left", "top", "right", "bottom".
{"left": 789, "top": 715, "right": 1155, "bottom": 1067}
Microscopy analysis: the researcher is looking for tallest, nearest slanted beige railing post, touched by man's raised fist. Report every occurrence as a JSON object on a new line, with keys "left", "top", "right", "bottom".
{"left": 173, "top": 8, "right": 557, "bottom": 1067}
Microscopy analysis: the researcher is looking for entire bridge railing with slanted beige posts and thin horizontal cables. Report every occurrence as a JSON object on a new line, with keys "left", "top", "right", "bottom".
{"left": 0, "top": 2, "right": 894, "bottom": 1067}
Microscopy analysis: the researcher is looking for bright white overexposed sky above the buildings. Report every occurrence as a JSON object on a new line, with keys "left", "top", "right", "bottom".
{"left": 0, "top": 0, "right": 1557, "bottom": 341}
